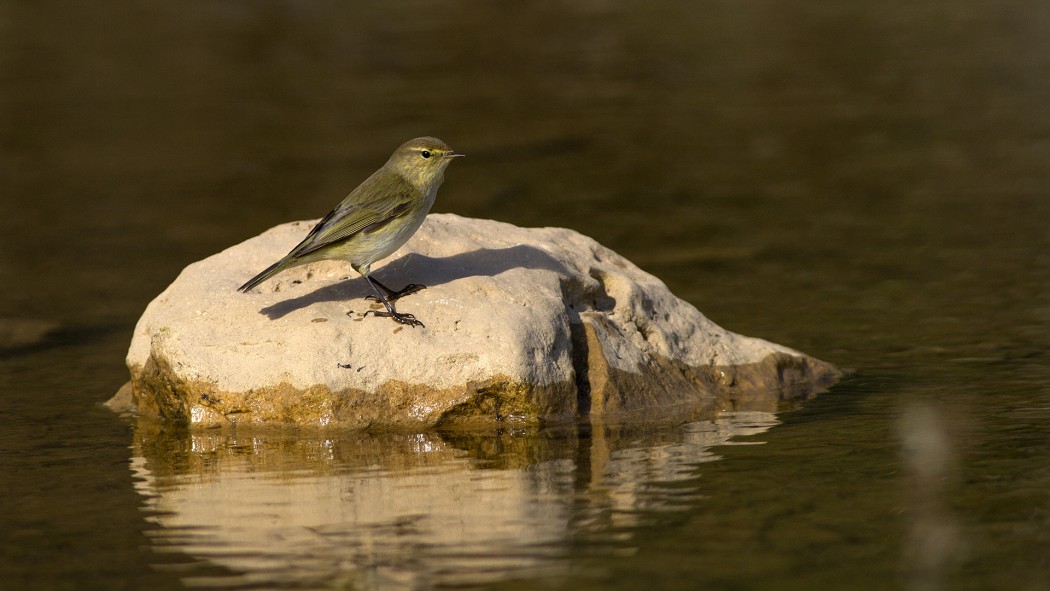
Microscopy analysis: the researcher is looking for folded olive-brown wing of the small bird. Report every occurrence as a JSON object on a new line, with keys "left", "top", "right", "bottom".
{"left": 288, "top": 175, "right": 418, "bottom": 258}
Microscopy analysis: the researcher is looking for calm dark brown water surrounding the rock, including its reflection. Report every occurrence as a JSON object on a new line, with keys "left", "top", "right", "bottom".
{"left": 0, "top": 0, "right": 1050, "bottom": 590}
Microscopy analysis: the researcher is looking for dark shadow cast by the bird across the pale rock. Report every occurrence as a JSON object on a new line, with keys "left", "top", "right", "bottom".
{"left": 259, "top": 245, "right": 567, "bottom": 320}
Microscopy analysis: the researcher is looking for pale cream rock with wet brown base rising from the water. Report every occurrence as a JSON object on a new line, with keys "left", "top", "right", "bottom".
{"left": 120, "top": 214, "right": 838, "bottom": 427}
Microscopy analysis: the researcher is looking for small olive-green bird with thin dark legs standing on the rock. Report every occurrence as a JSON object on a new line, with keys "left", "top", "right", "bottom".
{"left": 237, "top": 138, "right": 463, "bottom": 326}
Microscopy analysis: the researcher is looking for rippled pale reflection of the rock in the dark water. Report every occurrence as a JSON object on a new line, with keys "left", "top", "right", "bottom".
{"left": 132, "top": 411, "right": 775, "bottom": 589}
